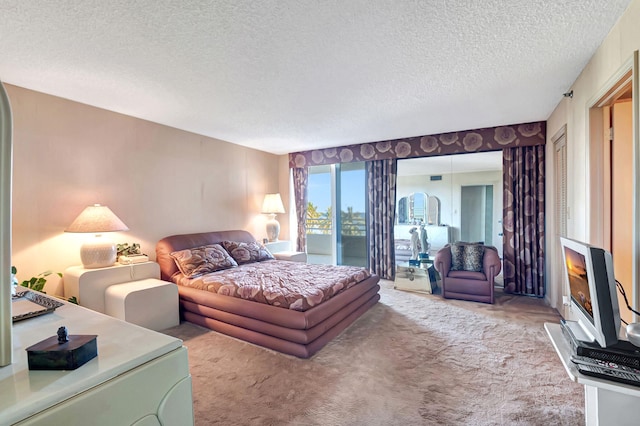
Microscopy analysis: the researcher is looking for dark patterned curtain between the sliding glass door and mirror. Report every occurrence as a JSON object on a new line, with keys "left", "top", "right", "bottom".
{"left": 366, "top": 159, "right": 398, "bottom": 280}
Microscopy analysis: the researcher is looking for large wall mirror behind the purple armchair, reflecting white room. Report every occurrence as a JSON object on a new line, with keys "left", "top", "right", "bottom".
{"left": 394, "top": 151, "right": 503, "bottom": 261}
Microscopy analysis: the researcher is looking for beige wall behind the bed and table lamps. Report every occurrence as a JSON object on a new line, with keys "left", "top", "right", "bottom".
{"left": 6, "top": 85, "right": 289, "bottom": 294}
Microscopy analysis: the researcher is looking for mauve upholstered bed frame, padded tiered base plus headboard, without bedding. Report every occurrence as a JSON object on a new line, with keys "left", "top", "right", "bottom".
{"left": 156, "top": 231, "right": 380, "bottom": 358}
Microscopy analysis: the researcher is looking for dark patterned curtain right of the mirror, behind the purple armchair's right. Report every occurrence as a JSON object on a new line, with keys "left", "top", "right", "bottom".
{"left": 503, "top": 145, "right": 545, "bottom": 297}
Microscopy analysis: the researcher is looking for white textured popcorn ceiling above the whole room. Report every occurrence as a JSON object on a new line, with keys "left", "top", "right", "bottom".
{"left": 0, "top": 0, "right": 630, "bottom": 154}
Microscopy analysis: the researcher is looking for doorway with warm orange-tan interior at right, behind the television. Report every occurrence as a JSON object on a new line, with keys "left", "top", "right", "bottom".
{"left": 588, "top": 51, "right": 640, "bottom": 323}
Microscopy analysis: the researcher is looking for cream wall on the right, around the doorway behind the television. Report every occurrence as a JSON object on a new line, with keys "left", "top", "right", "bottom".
{"left": 546, "top": 0, "right": 640, "bottom": 309}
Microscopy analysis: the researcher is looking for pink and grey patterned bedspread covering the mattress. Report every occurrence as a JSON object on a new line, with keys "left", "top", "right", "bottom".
{"left": 174, "top": 260, "right": 371, "bottom": 311}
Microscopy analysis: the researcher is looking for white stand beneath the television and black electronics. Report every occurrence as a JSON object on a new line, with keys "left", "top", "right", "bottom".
{"left": 544, "top": 323, "right": 640, "bottom": 426}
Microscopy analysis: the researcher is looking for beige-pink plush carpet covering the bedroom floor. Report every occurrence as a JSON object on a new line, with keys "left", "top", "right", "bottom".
{"left": 162, "top": 282, "right": 584, "bottom": 425}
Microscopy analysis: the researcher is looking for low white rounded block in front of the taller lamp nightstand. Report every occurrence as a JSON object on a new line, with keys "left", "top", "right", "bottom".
{"left": 104, "top": 278, "right": 180, "bottom": 331}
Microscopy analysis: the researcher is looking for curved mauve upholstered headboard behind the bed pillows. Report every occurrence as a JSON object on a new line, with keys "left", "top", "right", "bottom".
{"left": 156, "top": 229, "right": 256, "bottom": 281}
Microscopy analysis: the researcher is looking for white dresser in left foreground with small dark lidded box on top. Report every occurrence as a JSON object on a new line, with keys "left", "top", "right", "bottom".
{"left": 0, "top": 303, "right": 193, "bottom": 426}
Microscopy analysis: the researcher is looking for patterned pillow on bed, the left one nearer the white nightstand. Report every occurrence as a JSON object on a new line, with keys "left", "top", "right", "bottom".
{"left": 171, "top": 244, "right": 238, "bottom": 278}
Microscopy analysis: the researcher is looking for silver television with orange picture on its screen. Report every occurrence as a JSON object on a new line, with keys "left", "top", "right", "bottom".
{"left": 560, "top": 237, "right": 620, "bottom": 348}
